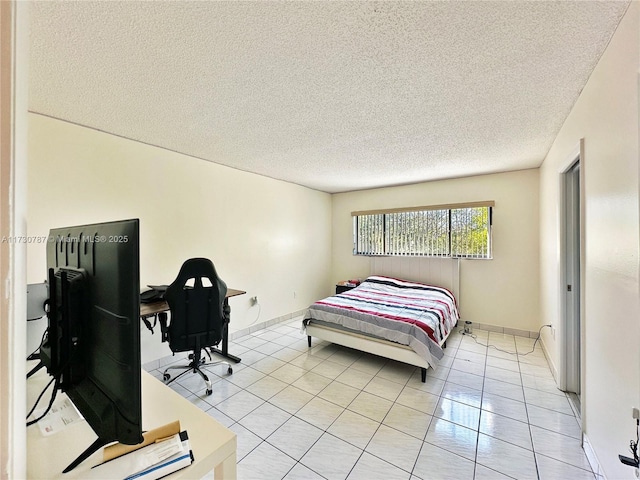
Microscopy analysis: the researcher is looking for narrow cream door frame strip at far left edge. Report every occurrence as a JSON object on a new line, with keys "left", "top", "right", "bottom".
{"left": 0, "top": 1, "right": 29, "bottom": 479}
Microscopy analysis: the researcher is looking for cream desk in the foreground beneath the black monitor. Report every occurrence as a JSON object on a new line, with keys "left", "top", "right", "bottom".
{"left": 27, "top": 370, "right": 236, "bottom": 480}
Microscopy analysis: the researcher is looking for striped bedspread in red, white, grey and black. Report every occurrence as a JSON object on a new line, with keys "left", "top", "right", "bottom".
{"left": 303, "top": 276, "right": 460, "bottom": 366}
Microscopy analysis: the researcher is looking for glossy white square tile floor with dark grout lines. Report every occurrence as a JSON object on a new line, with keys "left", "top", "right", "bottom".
{"left": 145, "top": 318, "right": 597, "bottom": 480}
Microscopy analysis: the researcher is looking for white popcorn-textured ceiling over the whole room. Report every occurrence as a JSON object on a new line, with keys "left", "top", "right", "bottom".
{"left": 30, "top": 1, "right": 628, "bottom": 192}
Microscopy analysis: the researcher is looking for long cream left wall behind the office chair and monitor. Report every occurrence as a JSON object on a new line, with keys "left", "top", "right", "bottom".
{"left": 27, "top": 114, "right": 331, "bottom": 362}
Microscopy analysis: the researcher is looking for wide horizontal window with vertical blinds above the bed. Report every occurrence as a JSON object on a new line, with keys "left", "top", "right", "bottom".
{"left": 351, "top": 202, "right": 494, "bottom": 258}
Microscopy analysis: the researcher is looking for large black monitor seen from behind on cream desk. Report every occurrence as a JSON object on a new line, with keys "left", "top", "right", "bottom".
{"left": 40, "top": 219, "right": 143, "bottom": 472}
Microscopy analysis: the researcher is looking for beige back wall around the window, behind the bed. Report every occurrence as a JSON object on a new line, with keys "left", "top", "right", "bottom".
{"left": 332, "top": 169, "right": 540, "bottom": 331}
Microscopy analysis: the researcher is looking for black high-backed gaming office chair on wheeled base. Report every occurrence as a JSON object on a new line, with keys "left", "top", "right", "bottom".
{"left": 163, "top": 258, "right": 233, "bottom": 395}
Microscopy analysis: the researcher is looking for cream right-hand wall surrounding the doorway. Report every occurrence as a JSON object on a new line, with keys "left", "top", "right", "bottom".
{"left": 540, "top": 2, "right": 640, "bottom": 478}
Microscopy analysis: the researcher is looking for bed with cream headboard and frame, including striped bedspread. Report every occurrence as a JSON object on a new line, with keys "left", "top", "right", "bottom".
{"left": 303, "top": 257, "right": 460, "bottom": 382}
